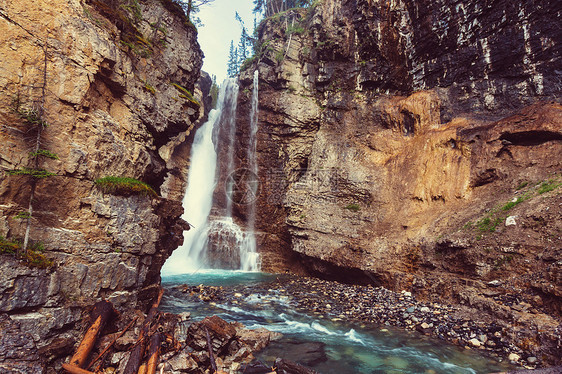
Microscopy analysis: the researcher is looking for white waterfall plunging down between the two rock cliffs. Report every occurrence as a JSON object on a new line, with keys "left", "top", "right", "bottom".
{"left": 162, "top": 71, "right": 260, "bottom": 275}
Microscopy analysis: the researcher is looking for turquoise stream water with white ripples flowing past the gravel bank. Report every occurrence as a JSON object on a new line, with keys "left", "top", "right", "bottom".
{"left": 161, "top": 270, "right": 507, "bottom": 374}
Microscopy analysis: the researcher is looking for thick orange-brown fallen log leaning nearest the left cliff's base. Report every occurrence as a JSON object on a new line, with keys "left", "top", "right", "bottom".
{"left": 69, "top": 300, "right": 116, "bottom": 368}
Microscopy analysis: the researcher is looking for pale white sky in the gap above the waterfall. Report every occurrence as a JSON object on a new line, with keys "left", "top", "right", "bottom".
{"left": 197, "top": 0, "right": 254, "bottom": 84}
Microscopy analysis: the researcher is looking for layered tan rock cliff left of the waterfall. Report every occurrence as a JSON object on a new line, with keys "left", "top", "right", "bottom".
{"left": 0, "top": 0, "right": 202, "bottom": 364}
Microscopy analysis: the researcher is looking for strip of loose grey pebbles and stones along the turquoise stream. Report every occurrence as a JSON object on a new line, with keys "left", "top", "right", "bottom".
{"left": 165, "top": 276, "right": 556, "bottom": 369}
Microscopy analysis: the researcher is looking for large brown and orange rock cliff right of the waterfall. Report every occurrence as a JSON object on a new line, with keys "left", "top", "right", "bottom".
{"left": 238, "top": 0, "right": 562, "bottom": 361}
